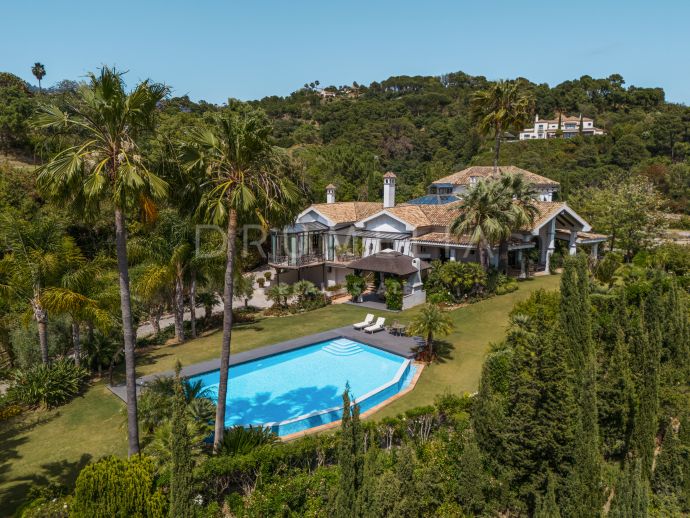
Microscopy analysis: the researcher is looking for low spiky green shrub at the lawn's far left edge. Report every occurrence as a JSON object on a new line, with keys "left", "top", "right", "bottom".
{"left": 8, "top": 359, "right": 89, "bottom": 408}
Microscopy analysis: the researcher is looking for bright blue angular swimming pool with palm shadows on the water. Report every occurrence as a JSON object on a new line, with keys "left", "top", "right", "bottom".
{"left": 189, "top": 338, "right": 415, "bottom": 436}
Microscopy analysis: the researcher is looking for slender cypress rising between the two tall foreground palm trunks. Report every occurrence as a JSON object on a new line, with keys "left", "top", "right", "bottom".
{"left": 170, "top": 362, "right": 194, "bottom": 518}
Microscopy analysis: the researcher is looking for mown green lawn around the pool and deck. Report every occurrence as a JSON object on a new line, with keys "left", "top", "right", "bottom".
{"left": 0, "top": 276, "right": 559, "bottom": 516}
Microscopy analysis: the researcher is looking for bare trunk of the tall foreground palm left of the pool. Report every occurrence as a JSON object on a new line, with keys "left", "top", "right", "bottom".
{"left": 111, "top": 208, "right": 139, "bottom": 455}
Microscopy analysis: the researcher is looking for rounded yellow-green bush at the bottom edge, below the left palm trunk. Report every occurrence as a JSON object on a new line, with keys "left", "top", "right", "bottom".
{"left": 70, "top": 455, "right": 167, "bottom": 518}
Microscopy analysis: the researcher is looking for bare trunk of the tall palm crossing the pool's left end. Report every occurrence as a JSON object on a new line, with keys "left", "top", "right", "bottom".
{"left": 213, "top": 209, "right": 237, "bottom": 452}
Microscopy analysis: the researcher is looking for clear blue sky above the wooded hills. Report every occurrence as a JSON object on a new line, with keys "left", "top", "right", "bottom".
{"left": 0, "top": 0, "right": 690, "bottom": 104}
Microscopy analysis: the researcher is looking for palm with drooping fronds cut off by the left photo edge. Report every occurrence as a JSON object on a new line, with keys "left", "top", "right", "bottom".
{"left": 0, "top": 214, "right": 74, "bottom": 364}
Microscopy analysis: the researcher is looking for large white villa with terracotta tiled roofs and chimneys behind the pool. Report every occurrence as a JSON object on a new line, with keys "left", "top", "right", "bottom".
{"left": 269, "top": 166, "right": 607, "bottom": 308}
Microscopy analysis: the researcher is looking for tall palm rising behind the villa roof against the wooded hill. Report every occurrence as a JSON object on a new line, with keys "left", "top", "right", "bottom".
{"left": 472, "top": 80, "right": 534, "bottom": 174}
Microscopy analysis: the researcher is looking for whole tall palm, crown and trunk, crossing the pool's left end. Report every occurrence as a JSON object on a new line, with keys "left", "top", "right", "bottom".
{"left": 183, "top": 111, "right": 298, "bottom": 451}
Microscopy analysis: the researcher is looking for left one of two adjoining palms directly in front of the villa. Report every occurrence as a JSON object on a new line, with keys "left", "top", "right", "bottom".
{"left": 449, "top": 180, "right": 514, "bottom": 269}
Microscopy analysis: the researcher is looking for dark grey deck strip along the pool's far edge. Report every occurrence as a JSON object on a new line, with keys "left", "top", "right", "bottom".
{"left": 108, "top": 326, "right": 417, "bottom": 402}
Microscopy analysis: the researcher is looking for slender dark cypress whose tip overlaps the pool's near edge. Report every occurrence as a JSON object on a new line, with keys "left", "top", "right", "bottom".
{"left": 334, "top": 386, "right": 364, "bottom": 518}
